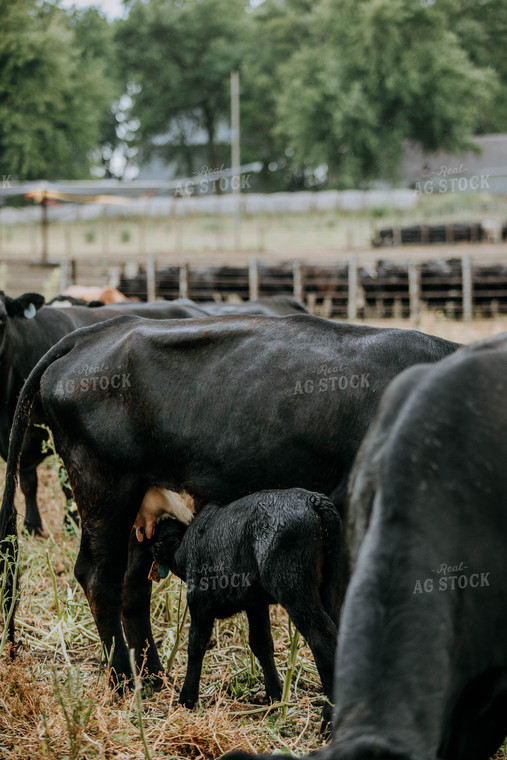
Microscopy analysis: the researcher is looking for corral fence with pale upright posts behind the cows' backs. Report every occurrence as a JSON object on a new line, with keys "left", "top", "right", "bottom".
{"left": 112, "top": 255, "right": 507, "bottom": 321}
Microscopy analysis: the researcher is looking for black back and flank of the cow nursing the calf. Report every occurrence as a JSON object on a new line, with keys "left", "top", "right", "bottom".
{"left": 41, "top": 316, "right": 456, "bottom": 510}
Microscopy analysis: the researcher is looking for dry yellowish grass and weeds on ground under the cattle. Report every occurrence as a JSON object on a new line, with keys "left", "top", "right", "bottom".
{"left": 0, "top": 314, "right": 507, "bottom": 760}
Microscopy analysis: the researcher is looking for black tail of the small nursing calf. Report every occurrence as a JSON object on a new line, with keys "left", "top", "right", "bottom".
{"left": 312, "top": 494, "right": 342, "bottom": 626}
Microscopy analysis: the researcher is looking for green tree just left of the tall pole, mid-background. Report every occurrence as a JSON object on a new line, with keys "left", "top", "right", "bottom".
{"left": 117, "top": 0, "right": 254, "bottom": 174}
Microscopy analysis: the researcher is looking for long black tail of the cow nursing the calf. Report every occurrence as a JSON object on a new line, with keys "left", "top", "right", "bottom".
{"left": 0, "top": 335, "right": 75, "bottom": 652}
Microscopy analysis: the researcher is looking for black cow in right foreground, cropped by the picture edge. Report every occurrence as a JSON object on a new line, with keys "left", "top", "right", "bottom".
{"left": 228, "top": 333, "right": 507, "bottom": 760}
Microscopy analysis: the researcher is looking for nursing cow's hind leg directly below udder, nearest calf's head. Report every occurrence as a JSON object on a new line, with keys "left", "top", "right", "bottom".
{"left": 121, "top": 531, "right": 163, "bottom": 674}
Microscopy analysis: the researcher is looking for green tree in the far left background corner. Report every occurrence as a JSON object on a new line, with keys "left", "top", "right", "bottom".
{"left": 0, "top": 0, "right": 118, "bottom": 179}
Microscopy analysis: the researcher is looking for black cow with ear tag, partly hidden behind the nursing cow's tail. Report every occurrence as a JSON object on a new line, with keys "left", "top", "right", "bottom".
{"left": 0, "top": 291, "right": 222, "bottom": 533}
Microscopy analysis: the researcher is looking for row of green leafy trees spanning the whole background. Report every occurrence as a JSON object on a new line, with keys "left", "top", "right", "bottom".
{"left": 0, "top": 0, "right": 507, "bottom": 190}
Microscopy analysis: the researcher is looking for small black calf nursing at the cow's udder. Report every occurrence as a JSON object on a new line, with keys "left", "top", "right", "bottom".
{"left": 153, "top": 488, "right": 341, "bottom": 724}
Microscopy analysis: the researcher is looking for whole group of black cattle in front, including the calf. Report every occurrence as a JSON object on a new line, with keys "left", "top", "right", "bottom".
{"left": 0, "top": 293, "right": 507, "bottom": 760}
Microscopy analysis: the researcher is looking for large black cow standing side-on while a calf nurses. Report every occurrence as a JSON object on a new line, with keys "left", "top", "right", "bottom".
{"left": 0, "top": 315, "right": 458, "bottom": 677}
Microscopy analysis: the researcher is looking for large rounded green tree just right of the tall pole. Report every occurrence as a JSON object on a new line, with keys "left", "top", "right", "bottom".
{"left": 277, "top": 0, "right": 497, "bottom": 187}
